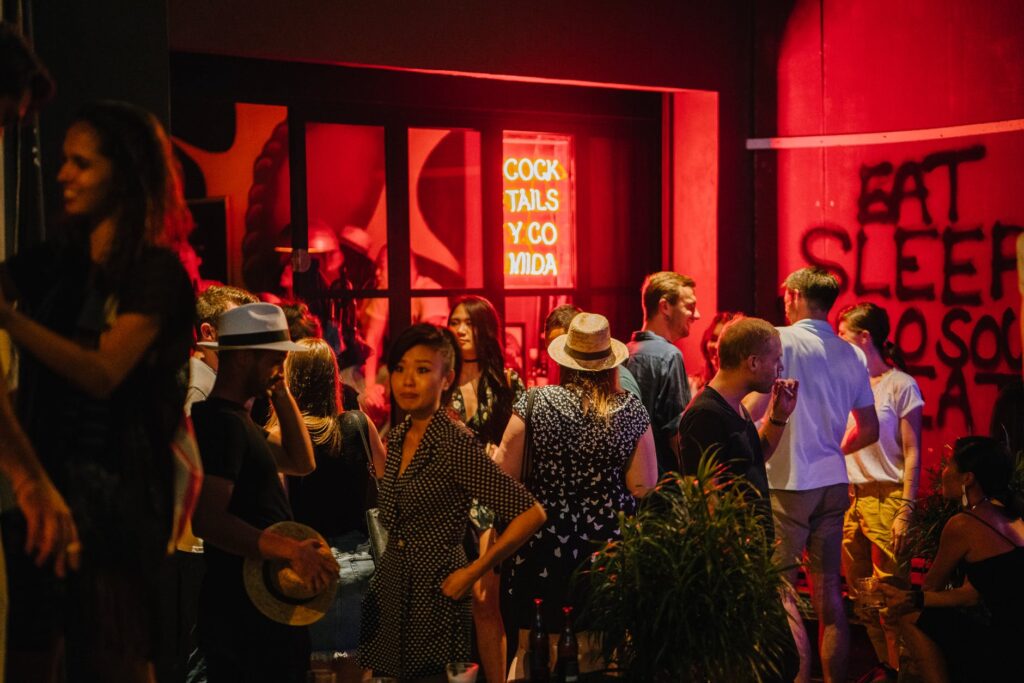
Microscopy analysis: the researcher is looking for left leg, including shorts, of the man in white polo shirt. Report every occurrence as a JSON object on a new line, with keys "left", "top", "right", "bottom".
{"left": 771, "top": 490, "right": 811, "bottom": 683}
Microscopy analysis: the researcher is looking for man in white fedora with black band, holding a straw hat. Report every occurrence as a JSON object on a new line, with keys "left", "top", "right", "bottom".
{"left": 193, "top": 303, "right": 338, "bottom": 683}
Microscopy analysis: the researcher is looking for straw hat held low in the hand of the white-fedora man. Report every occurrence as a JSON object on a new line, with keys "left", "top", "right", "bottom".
{"left": 242, "top": 522, "right": 338, "bottom": 626}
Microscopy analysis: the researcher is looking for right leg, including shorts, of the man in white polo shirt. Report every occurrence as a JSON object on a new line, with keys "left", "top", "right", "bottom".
{"left": 807, "top": 484, "right": 850, "bottom": 683}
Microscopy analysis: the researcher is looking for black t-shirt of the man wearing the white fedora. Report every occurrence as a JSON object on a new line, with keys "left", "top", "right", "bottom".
{"left": 191, "top": 398, "right": 292, "bottom": 602}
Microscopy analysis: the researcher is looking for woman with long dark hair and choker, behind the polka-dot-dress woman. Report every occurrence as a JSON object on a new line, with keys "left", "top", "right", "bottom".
{"left": 449, "top": 295, "right": 526, "bottom": 681}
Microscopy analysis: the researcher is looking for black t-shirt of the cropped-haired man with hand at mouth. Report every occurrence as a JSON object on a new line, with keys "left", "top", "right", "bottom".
{"left": 679, "top": 386, "right": 774, "bottom": 542}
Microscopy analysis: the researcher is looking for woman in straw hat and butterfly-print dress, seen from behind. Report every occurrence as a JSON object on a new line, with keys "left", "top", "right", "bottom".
{"left": 496, "top": 313, "right": 657, "bottom": 667}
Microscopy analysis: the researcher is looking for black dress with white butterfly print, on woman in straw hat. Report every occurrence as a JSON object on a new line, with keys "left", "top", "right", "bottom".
{"left": 510, "top": 386, "right": 650, "bottom": 631}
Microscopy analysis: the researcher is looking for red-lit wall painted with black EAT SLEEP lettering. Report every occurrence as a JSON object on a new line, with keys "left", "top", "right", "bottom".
{"left": 770, "top": 0, "right": 1024, "bottom": 465}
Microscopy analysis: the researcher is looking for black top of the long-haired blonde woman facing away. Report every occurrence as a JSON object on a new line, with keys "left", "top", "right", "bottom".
{"left": 288, "top": 411, "right": 371, "bottom": 539}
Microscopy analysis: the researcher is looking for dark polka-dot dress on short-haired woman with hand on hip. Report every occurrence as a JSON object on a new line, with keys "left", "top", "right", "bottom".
{"left": 359, "top": 409, "right": 534, "bottom": 678}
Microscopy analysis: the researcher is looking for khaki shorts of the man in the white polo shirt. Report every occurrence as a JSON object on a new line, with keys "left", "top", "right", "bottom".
{"left": 771, "top": 483, "right": 850, "bottom": 585}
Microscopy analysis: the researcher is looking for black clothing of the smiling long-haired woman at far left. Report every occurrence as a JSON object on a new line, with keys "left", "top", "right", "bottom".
{"left": 3, "top": 244, "right": 196, "bottom": 570}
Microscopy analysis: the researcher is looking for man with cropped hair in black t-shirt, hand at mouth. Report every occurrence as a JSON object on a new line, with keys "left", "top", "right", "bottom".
{"left": 679, "top": 317, "right": 798, "bottom": 543}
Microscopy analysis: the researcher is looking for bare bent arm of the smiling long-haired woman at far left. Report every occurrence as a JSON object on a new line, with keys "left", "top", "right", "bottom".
{"left": 0, "top": 297, "right": 160, "bottom": 398}
